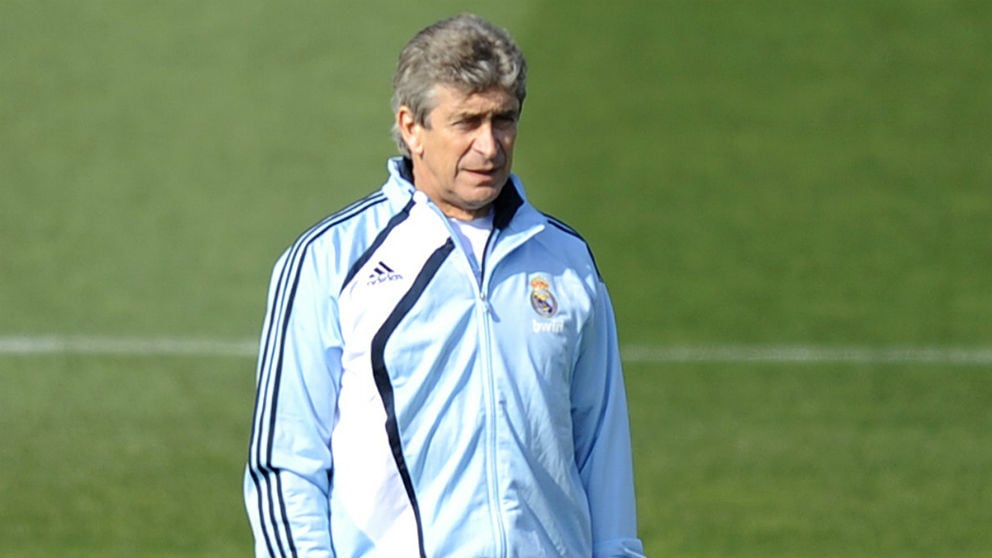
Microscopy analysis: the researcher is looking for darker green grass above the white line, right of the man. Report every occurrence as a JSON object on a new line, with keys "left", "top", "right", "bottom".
{"left": 521, "top": 0, "right": 992, "bottom": 344}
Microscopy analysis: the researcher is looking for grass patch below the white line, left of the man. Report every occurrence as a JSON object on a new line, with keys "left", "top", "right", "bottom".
{"left": 0, "top": 356, "right": 253, "bottom": 558}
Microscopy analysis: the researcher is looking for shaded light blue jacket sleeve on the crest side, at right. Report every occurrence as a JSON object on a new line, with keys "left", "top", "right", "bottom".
{"left": 572, "top": 281, "right": 644, "bottom": 558}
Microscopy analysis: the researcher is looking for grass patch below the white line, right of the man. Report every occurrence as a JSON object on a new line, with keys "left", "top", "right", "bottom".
{"left": 628, "top": 364, "right": 992, "bottom": 557}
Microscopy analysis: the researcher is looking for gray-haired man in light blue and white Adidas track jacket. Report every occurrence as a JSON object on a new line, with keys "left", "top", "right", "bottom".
{"left": 245, "top": 15, "right": 643, "bottom": 558}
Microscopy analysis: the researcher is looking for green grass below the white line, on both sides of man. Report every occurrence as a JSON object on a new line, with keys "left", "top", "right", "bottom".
{"left": 0, "top": 356, "right": 992, "bottom": 558}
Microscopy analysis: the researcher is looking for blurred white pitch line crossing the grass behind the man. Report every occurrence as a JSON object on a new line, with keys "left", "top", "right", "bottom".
{"left": 0, "top": 335, "right": 992, "bottom": 366}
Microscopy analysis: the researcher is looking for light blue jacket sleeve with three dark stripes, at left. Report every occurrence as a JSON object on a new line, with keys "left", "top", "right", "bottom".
{"left": 244, "top": 248, "right": 341, "bottom": 557}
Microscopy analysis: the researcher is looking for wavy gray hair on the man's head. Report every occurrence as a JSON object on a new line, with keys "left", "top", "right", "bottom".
{"left": 392, "top": 14, "right": 527, "bottom": 157}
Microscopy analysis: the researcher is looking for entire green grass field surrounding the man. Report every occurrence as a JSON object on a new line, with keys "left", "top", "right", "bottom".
{"left": 0, "top": 0, "right": 992, "bottom": 558}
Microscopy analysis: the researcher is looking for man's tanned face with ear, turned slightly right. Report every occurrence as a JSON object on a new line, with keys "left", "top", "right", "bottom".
{"left": 396, "top": 85, "right": 520, "bottom": 220}
